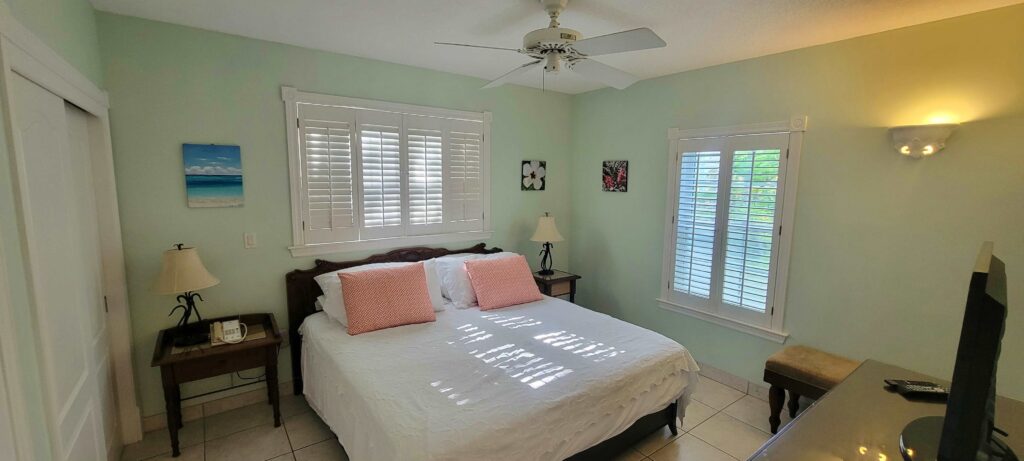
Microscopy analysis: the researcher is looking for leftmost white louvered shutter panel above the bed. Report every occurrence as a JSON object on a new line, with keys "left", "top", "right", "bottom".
{"left": 298, "top": 104, "right": 358, "bottom": 243}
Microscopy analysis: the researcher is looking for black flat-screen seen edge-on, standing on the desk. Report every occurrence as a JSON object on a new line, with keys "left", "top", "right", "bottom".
{"left": 900, "top": 242, "right": 1017, "bottom": 461}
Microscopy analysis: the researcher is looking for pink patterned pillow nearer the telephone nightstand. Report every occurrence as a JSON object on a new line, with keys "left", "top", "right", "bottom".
{"left": 338, "top": 262, "right": 436, "bottom": 335}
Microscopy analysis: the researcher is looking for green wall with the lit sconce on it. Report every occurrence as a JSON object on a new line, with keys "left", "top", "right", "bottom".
{"left": 567, "top": 6, "right": 1024, "bottom": 399}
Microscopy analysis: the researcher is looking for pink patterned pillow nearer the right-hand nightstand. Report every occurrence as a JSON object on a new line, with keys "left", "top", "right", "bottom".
{"left": 466, "top": 255, "right": 544, "bottom": 310}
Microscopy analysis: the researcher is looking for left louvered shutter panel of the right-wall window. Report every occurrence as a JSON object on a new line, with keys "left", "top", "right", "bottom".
{"left": 673, "top": 152, "right": 721, "bottom": 298}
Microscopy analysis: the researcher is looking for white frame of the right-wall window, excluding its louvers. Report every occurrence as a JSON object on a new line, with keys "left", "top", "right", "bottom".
{"left": 657, "top": 116, "right": 807, "bottom": 343}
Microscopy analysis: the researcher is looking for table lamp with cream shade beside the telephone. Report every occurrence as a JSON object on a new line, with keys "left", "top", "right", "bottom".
{"left": 153, "top": 244, "right": 220, "bottom": 347}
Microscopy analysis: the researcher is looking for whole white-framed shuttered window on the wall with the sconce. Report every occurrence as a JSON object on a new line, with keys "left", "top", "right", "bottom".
{"left": 660, "top": 118, "right": 806, "bottom": 341}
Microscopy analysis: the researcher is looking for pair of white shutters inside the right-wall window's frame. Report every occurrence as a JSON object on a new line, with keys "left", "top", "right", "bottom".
{"left": 666, "top": 133, "right": 788, "bottom": 327}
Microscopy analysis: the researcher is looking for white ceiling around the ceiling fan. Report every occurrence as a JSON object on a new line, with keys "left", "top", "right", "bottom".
{"left": 91, "top": 0, "right": 1024, "bottom": 93}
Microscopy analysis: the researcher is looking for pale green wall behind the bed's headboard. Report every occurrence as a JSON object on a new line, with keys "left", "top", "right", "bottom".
{"left": 97, "top": 13, "right": 571, "bottom": 415}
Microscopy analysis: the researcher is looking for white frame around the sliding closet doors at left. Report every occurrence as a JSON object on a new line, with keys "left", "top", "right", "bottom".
{"left": 0, "top": 2, "right": 142, "bottom": 452}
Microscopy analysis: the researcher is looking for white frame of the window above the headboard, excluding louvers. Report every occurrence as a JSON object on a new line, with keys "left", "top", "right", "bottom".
{"left": 281, "top": 86, "right": 494, "bottom": 257}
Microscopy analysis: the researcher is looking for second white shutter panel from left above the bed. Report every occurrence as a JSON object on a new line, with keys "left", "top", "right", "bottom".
{"left": 356, "top": 111, "right": 404, "bottom": 239}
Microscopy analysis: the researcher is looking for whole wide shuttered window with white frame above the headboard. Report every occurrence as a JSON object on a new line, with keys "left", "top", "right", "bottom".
{"left": 282, "top": 87, "right": 490, "bottom": 256}
